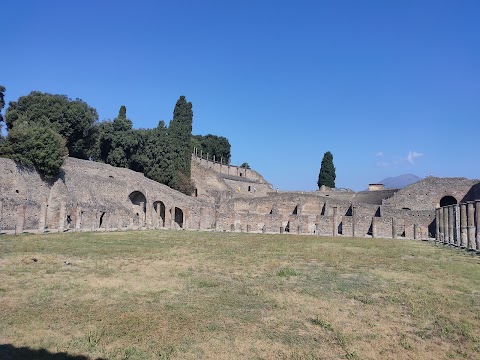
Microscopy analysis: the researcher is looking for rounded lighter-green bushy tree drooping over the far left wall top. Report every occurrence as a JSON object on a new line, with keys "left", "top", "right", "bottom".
{"left": 0, "top": 124, "right": 67, "bottom": 180}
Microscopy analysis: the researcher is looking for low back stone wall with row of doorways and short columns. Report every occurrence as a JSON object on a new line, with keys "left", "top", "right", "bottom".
{"left": 215, "top": 193, "right": 435, "bottom": 239}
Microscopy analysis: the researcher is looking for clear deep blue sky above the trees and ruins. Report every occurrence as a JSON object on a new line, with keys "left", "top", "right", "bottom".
{"left": 0, "top": 0, "right": 480, "bottom": 190}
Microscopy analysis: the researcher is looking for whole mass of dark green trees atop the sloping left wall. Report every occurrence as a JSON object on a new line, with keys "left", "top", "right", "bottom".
{"left": 0, "top": 86, "right": 230, "bottom": 195}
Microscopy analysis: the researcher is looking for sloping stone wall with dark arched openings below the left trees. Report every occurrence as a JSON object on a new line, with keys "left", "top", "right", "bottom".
{"left": 0, "top": 158, "right": 214, "bottom": 232}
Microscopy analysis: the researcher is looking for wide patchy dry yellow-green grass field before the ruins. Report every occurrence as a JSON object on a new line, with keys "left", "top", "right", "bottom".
{"left": 0, "top": 231, "right": 480, "bottom": 359}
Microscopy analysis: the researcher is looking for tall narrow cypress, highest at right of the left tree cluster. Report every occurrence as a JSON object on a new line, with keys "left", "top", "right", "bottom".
{"left": 167, "top": 96, "right": 193, "bottom": 195}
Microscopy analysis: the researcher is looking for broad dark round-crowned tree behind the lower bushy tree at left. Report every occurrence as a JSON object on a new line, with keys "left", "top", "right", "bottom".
{"left": 5, "top": 91, "right": 98, "bottom": 159}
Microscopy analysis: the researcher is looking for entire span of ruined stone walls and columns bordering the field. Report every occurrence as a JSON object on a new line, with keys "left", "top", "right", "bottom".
{"left": 0, "top": 155, "right": 480, "bottom": 249}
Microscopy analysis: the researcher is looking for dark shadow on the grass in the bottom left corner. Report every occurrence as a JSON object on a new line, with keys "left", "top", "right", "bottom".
{"left": 0, "top": 344, "right": 104, "bottom": 360}
